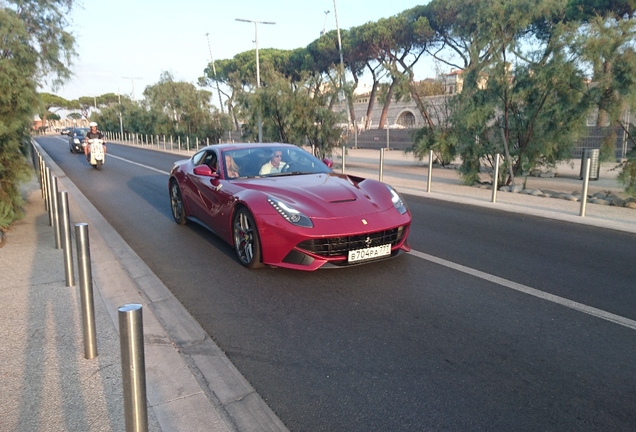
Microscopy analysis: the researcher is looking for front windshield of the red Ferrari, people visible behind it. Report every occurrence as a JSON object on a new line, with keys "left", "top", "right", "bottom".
{"left": 221, "top": 147, "right": 332, "bottom": 179}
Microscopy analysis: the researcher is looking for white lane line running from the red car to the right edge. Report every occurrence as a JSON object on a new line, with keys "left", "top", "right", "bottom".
{"left": 409, "top": 250, "right": 636, "bottom": 330}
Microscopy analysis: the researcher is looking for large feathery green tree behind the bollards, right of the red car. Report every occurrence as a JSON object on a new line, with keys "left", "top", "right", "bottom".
{"left": 455, "top": 0, "right": 589, "bottom": 184}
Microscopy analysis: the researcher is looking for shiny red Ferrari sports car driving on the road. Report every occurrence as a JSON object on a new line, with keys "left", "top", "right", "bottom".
{"left": 168, "top": 144, "right": 411, "bottom": 270}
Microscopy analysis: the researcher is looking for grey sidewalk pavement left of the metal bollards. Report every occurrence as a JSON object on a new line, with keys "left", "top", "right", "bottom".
{"left": 0, "top": 176, "right": 153, "bottom": 431}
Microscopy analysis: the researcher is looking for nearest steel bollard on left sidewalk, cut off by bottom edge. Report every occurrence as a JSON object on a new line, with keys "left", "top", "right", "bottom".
{"left": 119, "top": 303, "right": 148, "bottom": 432}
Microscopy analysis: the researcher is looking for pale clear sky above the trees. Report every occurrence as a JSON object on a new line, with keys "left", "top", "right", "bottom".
{"left": 42, "top": 0, "right": 434, "bottom": 107}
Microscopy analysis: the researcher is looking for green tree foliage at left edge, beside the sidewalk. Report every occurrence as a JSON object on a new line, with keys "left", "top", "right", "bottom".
{"left": 0, "top": 0, "right": 74, "bottom": 230}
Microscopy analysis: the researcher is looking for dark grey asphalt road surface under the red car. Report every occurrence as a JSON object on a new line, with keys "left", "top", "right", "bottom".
{"left": 38, "top": 137, "right": 636, "bottom": 431}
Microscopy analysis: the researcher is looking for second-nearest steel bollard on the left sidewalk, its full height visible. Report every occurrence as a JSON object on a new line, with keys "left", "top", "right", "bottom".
{"left": 75, "top": 223, "right": 97, "bottom": 360}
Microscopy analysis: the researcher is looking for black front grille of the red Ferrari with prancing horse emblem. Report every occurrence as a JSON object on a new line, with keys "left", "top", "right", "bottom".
{"left": 297, "top": 226, "right": 406, "bottom": 258}
